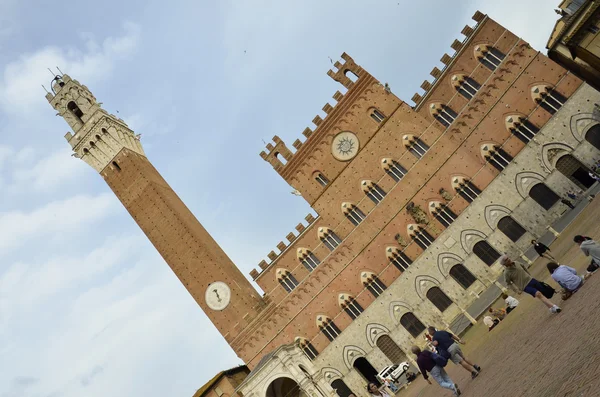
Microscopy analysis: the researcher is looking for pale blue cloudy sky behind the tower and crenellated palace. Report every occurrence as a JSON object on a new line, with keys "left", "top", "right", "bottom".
{"left": 0, "top": 0, "right": 558, "bottom": 397}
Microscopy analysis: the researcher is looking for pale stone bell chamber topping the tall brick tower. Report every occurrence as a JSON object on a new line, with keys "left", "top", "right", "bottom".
{"left": 46, "top": 74, "right": 145, "bottom": 172}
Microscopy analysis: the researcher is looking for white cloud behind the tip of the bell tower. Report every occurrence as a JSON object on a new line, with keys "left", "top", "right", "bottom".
{"left": 0, "top": 22, "right": 140, "bottom": 113}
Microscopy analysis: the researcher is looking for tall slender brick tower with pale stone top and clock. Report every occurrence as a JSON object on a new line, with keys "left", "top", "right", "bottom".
{"left": 46, "top": 75, "right": 264, "bottom": 343}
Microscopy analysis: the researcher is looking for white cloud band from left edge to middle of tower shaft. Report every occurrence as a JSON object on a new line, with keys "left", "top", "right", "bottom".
{"left": 0, "top": 193, "right": 118, "bottom": 256}
